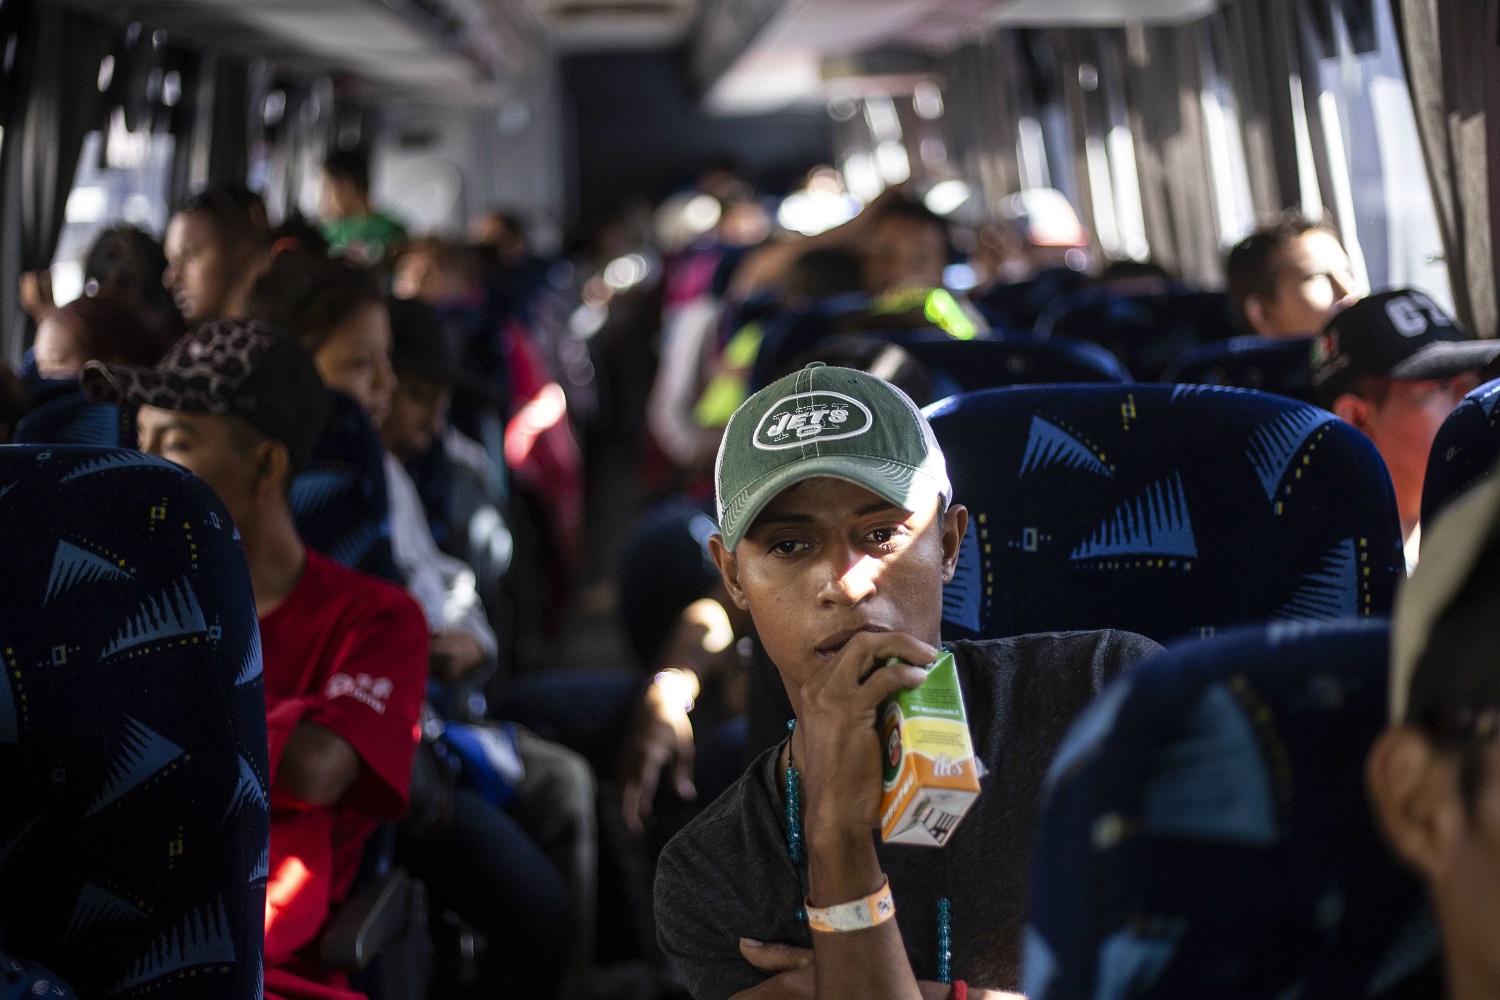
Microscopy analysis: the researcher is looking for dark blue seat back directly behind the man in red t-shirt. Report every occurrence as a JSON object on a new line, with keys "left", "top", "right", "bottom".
{"left": 291, "top": 393, "right": 402, "bottom": 583}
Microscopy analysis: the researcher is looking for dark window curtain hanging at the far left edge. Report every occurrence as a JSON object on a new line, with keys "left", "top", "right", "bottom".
{"left": 0, "top": 0, "right": 113, "bottom": 363}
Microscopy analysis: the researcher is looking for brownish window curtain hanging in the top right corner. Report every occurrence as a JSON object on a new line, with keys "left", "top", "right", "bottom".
{"left": 1394, "top": 0, "right": 1500, "bottom": 337}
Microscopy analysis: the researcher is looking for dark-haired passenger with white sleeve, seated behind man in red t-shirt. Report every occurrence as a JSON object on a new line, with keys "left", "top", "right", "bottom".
{"left": 249, "top": 250, "right": 498, "bottom": 681}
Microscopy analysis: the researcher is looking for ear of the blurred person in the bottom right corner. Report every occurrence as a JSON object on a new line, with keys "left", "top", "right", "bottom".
{"left": 1365, "top": 726, "right": 1467, "bottom": 882}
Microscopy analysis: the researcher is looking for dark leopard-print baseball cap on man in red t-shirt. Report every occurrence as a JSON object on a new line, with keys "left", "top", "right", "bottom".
{"left": 83, "top": 319, "right": 333, "bottom": 469}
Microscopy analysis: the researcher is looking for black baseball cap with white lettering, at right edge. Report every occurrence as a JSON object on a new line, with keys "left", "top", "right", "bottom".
{"left": 1308, "top": 288, "right": 1500, "bottom": 406}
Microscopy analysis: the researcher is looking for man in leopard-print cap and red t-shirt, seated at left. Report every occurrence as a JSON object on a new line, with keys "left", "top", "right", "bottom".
{"left": 83, "top": 319, "right": 428, "bottom": 1000}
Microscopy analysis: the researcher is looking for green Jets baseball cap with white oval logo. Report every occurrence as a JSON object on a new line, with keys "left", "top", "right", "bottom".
{"left": 714, "top": 361, "right": 953, "bottom": 550}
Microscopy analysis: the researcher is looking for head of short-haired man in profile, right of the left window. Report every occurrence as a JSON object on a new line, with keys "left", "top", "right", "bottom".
{"left": 162, "top": 187, "right": 270, "bottom": 327}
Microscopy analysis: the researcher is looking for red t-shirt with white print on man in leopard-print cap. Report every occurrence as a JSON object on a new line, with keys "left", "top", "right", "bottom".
{"left": 261, "top": 550, "right": 428, "bottom": 996}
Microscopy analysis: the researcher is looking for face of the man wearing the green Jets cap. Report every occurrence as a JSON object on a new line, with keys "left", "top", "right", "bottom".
{"left": 714, "top": 477, "right": 968, "bottom": 705}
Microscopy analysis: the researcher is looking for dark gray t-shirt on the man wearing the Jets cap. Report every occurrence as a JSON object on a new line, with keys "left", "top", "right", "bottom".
{"left": 656, "top": 631, "right": 1161, "bottom": 1000}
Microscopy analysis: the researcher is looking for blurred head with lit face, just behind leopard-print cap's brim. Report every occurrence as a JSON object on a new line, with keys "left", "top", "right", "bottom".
{"left": 32, "top": 294, "right": 171, "bottom": 379}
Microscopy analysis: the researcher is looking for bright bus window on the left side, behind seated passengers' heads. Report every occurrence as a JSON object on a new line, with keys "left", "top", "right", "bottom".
{"left": 53, "top": 117, "right": 177, "bottom": 306}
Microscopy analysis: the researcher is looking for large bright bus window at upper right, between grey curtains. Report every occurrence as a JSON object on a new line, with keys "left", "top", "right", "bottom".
{"left": 1304, "top": 0, "right": 1454, "bottom": 312}
